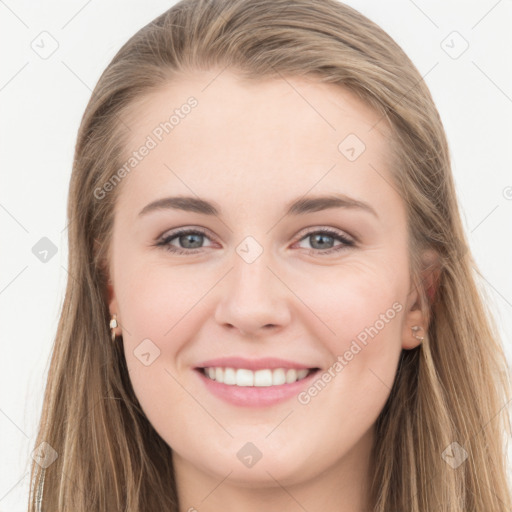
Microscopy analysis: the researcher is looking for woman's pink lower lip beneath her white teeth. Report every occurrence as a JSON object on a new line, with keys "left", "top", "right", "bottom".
{"left": 195, "top": 369, "right": 319, "bottom": 407}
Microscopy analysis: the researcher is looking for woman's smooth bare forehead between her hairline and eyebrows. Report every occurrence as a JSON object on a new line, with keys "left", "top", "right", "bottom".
{"left": 115, "top": 70, "right": 393, "bottom": 220}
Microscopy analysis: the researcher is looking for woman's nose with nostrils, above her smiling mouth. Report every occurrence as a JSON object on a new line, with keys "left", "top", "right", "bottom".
{"left": 215, "top": 247, "right": 291, "bottom": 337}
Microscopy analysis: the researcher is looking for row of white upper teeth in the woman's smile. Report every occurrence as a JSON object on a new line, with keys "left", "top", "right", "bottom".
{"left": 204, "top": 367, "right": 309, "bottom": 387}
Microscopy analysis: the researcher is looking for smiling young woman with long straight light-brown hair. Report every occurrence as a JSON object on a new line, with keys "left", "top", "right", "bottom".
{"left": 29, "top": 0, "right": 512, "bottom": 512}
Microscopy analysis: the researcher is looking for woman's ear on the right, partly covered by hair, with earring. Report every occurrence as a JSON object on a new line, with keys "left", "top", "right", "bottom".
{"left": 402, "top": 249, "right": 441, "bottom": 350}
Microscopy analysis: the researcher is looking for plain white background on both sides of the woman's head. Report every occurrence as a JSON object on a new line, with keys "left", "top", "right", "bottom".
{"left": 0, "top": 0, "right": 512, "bottom": 512}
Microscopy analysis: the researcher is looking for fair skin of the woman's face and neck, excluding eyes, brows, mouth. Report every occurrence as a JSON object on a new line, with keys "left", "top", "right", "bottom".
{"left": 109, "top": 70, "right": 427, "bottom": 512}
